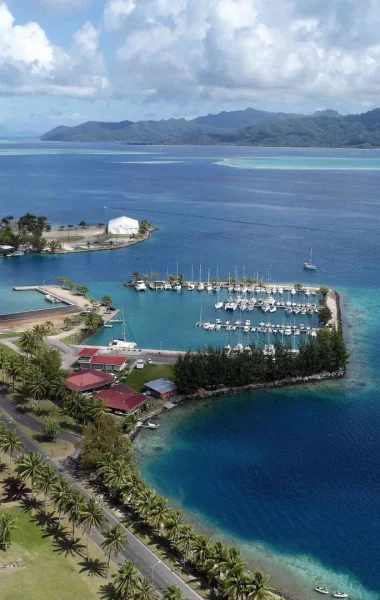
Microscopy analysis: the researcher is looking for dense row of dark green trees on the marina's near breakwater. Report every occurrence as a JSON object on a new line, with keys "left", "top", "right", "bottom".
{"left": 174, "top": 329, "right": 348, "bottom": 393}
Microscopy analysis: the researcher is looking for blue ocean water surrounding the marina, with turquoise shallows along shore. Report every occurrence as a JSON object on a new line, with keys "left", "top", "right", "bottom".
{"left": 0, "top": 144, "right": 380, "bottom": 600}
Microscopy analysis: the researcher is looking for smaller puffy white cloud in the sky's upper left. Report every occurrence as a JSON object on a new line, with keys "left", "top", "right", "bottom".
{"left": 0, "top": 2, "right": 109, "bottom": 98}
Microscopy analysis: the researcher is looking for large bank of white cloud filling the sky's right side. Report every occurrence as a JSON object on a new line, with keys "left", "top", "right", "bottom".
{"left": 104, "top": 0, "right": 380, "bottom": 105}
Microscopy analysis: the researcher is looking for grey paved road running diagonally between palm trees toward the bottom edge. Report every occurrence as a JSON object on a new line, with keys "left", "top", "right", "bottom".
{"left": 3, "top": 408, "right": 202, "bottom": 600}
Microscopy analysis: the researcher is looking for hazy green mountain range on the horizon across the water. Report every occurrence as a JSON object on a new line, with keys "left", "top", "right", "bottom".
{"left": 40, "top": 108, "right": 380, "bottom": 148}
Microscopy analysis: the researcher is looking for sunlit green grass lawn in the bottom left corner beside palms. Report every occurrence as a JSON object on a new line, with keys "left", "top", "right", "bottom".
{"left": 0, "top": 507, "right": 110, "bottom": 600}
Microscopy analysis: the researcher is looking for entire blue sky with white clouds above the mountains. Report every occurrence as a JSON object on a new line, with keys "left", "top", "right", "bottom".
{"left": 0, "top": 0, "right": 380, "bottom": 133}
